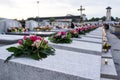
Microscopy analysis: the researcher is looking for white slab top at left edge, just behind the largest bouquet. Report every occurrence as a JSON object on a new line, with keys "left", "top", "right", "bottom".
{"left": 0, "top": 34, "right": 23, "bottom": 41}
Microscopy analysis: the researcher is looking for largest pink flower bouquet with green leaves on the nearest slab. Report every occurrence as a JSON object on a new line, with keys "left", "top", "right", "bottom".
{"left": 5, "top": 35, "right": 55, "bottom": 62}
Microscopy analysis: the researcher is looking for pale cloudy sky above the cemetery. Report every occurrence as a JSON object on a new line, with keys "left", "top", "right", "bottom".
{"left": 0, "top": 0, "right": 120, "bottom": 19}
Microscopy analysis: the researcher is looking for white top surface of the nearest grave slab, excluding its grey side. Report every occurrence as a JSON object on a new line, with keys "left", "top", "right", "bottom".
{"left": 0, "top": 44, "right": 101, "bottom": 80}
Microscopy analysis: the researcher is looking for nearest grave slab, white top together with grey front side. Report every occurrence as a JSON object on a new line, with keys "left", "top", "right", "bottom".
{"left": 0, "top": 44, "right": 101, "bottom": 80}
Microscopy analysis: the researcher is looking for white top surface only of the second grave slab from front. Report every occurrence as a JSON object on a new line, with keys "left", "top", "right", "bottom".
{"left": 45, "top": 38, "right": 102, "bottom": 52}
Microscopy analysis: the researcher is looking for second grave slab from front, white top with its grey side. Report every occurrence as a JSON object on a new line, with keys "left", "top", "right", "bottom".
{"left": 45, "top": 38, "right": 102, "bottom": 55}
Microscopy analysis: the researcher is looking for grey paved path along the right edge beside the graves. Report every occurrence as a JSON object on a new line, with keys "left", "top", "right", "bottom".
{"left": 107, "top": 31, "right": 120, "bottom": 80}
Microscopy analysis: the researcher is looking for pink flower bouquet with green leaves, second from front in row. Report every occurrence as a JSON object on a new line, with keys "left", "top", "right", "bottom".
{"left": 49, "top": 31, "right": 72, "bottom": 43}
